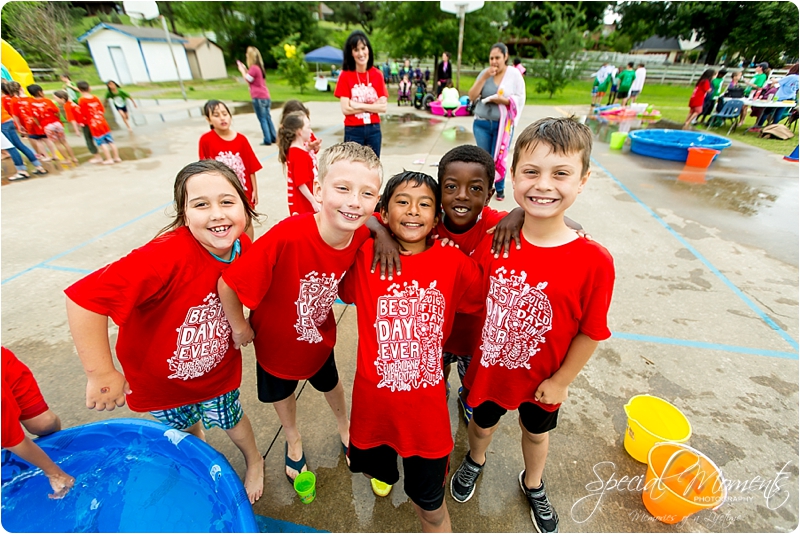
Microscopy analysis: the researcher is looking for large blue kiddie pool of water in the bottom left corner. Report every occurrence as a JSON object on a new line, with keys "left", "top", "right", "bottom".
{"left": 2, "top": 419, "right": 258, "bottom": 532}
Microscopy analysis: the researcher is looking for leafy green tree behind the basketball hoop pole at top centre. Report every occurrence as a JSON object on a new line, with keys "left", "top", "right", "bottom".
{"left": 376, "top": 2, "right": 511, "bottom": 88}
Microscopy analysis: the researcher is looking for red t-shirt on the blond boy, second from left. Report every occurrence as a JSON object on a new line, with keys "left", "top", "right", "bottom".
{"left": 222, "top": 213, "right": 369, "bottom": 380}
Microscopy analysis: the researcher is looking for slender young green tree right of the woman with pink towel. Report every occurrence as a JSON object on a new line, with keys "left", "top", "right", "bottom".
{"left": 533, "top": 4, "right": 584, "bottom": 98}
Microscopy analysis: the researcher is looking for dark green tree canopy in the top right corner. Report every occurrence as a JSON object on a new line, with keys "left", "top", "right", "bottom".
{"left": 616, "top": 1, "right": 798, "bottom": 64}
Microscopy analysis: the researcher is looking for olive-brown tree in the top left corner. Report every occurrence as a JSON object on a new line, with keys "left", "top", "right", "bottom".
{"left": 3, "top": 2, "right": 75, "bottom": 72}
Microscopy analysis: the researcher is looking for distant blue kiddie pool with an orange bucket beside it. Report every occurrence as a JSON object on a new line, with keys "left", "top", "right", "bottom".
{"left": 628, "top": 129, "right": 731, "bottom": 161}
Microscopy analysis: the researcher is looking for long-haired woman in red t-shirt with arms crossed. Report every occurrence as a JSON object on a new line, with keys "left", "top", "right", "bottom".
{"left": 333, "top": 30, "right": 389, "bottom": 157}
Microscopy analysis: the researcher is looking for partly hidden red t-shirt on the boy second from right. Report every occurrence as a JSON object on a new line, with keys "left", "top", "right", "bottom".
{"left": 433, "top": 206, "right": 507, "bottom": 356}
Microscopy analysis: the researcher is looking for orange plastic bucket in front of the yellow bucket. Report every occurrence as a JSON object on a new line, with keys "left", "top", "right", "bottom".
{"left": 642, "top": 443, "right": 728, "bottom": 524}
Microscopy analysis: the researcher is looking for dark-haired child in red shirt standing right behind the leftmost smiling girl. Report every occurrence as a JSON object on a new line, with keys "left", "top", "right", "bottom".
{"left": 198, "top": 100, "right": 261, "bottom": 240}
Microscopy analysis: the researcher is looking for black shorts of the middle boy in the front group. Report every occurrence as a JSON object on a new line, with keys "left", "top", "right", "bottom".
{"left": 348, "top": 443, "right": 450, "bottom": 511}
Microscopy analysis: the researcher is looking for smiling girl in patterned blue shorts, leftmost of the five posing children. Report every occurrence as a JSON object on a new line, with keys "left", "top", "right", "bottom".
{"left": 65, "top": 160, "right": 264, "bottom": 503}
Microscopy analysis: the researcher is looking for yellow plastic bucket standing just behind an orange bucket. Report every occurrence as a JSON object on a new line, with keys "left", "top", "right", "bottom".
{"left": 625, "top": 395, "right": 692, "bottom": 464}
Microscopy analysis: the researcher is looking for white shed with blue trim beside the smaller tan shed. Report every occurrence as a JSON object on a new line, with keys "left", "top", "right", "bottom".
{"left": 78, "top": 22, "right": 192, "bottom": 85}
